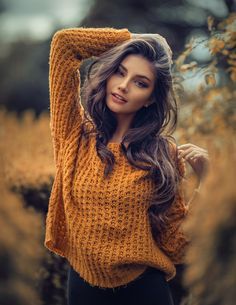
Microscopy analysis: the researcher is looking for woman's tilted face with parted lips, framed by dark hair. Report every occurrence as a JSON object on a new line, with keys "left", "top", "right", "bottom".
{"left": 106, "top": 54, "right": 155, "bottom": 114}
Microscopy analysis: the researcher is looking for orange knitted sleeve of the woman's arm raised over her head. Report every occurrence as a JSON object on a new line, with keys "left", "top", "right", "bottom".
{"left": 49, "top": 28, "right": 131, "bottom": 166}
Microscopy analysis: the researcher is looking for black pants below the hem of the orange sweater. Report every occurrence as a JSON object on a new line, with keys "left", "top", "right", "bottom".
{"left": 67, "top": 265, "right": 174, "bottom": 305}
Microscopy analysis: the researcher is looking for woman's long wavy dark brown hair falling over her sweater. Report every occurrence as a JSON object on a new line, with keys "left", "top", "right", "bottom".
{"left": 82, "top": 37, "right": 183, "bottom": 235}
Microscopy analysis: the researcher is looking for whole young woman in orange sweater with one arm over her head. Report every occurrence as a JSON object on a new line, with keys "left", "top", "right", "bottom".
{"left": 45, "top": 28, "right": 207, "bottom": 305}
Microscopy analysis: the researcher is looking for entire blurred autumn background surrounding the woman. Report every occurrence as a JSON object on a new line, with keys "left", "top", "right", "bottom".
{"left": 0, "top": 0, "right": 236, "bottom": 305}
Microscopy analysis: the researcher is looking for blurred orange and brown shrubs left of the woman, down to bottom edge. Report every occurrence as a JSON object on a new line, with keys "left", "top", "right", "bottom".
{"left": 0, "top": 109, "right": 67, "bottom": 305}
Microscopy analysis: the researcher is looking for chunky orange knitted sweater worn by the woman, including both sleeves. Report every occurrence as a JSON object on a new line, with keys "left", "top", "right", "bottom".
{"left": 44, "top": 28, "right": 189, "bottom": 288}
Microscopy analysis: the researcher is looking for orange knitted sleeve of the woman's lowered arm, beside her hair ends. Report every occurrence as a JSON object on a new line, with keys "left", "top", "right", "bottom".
{"left": 157, "top": 142, "right": 190, "bottom": 265}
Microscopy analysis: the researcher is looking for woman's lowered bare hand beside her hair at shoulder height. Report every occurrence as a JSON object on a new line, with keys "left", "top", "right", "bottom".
{"left": 178, "top": 143, "right": 209, "bottom": 181}
